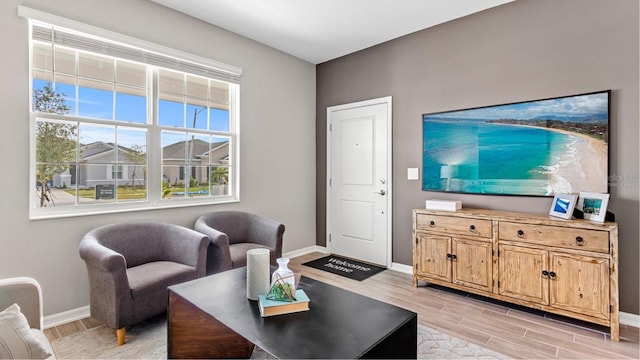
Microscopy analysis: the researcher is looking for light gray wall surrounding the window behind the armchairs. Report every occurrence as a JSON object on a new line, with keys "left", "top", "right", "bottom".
{"left": 0, "top": 0, "right": 315, "bottom": 315}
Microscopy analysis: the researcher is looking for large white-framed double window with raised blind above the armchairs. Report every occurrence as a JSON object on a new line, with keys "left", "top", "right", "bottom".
{"left": 30, "top": 16, "right": 241, "bottom": 218}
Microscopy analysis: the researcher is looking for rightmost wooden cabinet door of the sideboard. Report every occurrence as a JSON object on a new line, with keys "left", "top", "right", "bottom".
{"left": 549, "top": 252, "right": 610, "bottom": 319}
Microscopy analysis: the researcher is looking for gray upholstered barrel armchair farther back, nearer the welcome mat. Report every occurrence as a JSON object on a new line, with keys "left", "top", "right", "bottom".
{"left": 195, "top": 211, "right": 284, "bottom": 275}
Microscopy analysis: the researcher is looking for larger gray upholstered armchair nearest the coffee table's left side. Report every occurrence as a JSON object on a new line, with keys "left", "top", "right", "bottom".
{"left": 79, "top": 223, "right": 209, "bottom": 345}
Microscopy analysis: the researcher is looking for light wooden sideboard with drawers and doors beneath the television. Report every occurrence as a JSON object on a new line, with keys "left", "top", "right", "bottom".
{"left": 413, "top": 208, "right": 620, "bottom": 341}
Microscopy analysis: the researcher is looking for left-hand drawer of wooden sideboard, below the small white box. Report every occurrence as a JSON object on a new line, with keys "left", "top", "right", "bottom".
{"left": 416, "top": 214, "right": 493, "bottom": 238}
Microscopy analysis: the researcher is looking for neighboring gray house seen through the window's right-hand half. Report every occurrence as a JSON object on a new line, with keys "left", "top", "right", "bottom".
{"left": 162, "top": 139, "right": 229, "bottom": 185}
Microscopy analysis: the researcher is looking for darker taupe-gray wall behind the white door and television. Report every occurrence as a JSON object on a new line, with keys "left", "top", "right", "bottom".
{"left": 316, "top": 0, "right": 639, "bottom": 314}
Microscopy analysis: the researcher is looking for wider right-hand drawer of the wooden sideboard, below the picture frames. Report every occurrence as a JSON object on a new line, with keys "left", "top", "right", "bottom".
{"left": 498, "top": 221, "right": 609, "bottom": 253}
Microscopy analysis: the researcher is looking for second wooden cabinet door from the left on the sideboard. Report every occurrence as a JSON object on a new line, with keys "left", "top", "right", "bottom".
{"left": 451, "top": 238, "right": 492, "bottom": 292}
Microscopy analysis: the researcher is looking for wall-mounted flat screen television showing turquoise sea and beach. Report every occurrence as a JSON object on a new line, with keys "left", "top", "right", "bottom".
{"left": 422, "top": 90, "right": 611, "bottom": 196}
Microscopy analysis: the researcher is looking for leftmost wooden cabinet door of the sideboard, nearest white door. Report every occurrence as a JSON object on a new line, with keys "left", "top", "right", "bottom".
{"left": 413, "top": 232, "right": 451, "bottom": 282}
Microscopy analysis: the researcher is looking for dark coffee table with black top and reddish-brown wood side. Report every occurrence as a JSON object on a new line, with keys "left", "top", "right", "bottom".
{"left": 167, "top": 268, "right": 418, "bottom": 359}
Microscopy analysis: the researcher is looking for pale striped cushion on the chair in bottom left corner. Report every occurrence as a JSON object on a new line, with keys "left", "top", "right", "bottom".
{"left": 0, "top": 304, "right": 52, "bottom": 359}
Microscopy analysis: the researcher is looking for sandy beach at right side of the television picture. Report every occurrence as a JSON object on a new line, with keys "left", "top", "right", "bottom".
{"left": 549, "top": 129, "right": 608, "bottom": 194}
